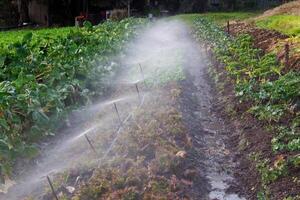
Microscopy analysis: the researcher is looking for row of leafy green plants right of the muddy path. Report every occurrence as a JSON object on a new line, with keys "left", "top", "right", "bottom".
{"left": 193, "top": 18, "right": 300, "bottom": 196}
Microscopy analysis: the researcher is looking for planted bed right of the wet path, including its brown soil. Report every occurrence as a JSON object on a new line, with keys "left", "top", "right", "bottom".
{"left": 193, "top": 17, "right": 300, "bottom": 199}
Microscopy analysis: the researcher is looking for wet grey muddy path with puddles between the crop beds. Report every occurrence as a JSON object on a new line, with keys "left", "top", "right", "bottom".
{"left": 180, "top": 32, "right": 245, "bottom": 200}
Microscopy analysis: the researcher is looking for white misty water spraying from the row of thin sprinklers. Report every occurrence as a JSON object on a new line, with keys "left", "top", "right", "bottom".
{"left": 0, "top": 21, "right": 245, "bottom": 200}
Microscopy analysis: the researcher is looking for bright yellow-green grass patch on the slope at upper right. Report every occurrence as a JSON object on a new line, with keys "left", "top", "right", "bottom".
{"left": 256, "top": 15, "right": 300, "bottom": 36}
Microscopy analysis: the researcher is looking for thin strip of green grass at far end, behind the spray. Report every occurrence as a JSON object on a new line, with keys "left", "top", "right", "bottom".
{"left": 175, "top": 12, "right": 259, "bottom": 25}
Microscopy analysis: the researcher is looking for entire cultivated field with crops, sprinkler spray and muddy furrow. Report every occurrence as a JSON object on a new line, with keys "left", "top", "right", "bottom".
{"left": 0, "top": 4, "right": 300, "bottom": 200}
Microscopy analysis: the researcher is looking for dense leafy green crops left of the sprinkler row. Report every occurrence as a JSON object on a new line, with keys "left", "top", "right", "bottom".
{"left": 0, "top": 19, "right": 144, "bottom": 180}
